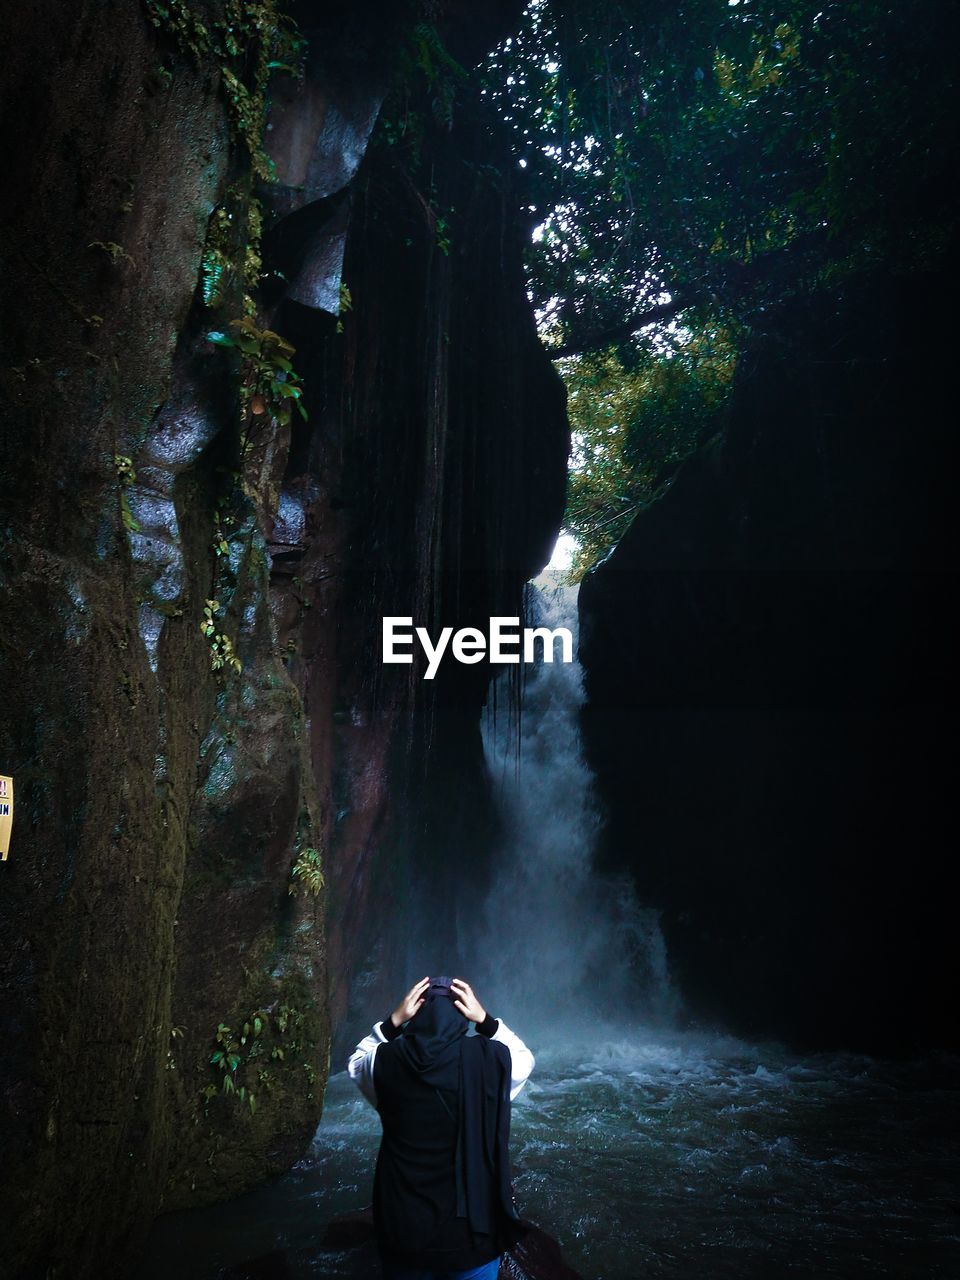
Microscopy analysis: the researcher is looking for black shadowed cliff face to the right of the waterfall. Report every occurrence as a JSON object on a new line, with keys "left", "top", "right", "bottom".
{"left": 580, "top": 267, "right": 956, "bottom": 1050}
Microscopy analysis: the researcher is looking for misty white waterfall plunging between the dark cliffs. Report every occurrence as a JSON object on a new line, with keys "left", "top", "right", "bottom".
{"left": 474, "top": 586, "right": 676, "bottom": 1038}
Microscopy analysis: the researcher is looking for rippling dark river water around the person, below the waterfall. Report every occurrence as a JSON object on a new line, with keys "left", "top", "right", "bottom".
{"left": 141, "top": 1028, "right": 960, "bottom": 1280}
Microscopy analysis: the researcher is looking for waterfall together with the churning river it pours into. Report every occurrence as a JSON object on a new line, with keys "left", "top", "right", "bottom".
{"left": 141, "top": 591, "right": 960, "bottom": 1280}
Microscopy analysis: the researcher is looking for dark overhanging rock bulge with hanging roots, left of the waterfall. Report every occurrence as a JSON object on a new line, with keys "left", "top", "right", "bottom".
{"left": 271, "top": 55, "right": 568, "bottom": 1052}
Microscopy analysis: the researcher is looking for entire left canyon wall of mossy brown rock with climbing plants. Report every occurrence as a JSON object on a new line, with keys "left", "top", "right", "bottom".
{"left": 0, "top": 3, "right": 567, "bottom": 1277}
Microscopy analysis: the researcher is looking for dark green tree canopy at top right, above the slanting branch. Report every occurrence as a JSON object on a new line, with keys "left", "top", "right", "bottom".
{"left": 486, "top": 0, "right": 955, "bottom": 351}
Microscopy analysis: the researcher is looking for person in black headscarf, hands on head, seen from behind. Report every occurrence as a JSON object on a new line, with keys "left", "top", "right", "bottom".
{"left": 347, "top": 978, "right": 534, "bottom": 1280}
